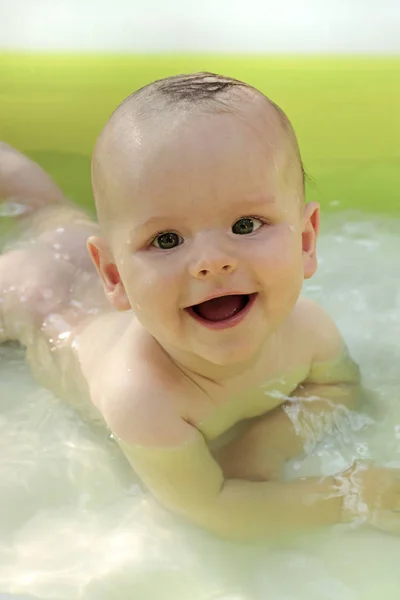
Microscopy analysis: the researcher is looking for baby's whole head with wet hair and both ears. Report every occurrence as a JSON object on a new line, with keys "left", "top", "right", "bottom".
{"left": 89, "top": 73, "right": 318, "bottom": 372}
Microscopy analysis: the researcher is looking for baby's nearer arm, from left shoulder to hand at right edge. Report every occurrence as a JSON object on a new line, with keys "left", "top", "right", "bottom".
{"left": 104, "top": 390, "right": 400, "bottom": 539}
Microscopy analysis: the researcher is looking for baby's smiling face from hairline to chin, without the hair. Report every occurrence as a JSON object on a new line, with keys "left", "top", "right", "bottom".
{"left": 103, "top": 105, "right": 315, "bottom": 365}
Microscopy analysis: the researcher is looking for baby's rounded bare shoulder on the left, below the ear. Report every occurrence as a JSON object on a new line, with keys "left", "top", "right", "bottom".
{"left": 86, "top": 324, "right": 202, "bottom": 447}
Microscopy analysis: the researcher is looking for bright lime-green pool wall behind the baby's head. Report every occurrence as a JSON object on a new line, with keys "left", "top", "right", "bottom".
{"left": 0, "top": 54, "right": 400, "bottom": 213}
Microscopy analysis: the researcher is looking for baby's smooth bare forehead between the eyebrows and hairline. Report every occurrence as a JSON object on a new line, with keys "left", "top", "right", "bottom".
{"left": 98, "top": 95, "right": 296, "bottom": 224}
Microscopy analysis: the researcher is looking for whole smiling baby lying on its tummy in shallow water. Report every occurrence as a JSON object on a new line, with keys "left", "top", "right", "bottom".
{"left": 0, "top": 73, "right": 400, "bottom": 539}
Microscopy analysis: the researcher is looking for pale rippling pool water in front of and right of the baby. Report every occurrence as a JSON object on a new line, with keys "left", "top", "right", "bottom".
{"left": 0, "top": 215, "right": 400, "bottom": 600}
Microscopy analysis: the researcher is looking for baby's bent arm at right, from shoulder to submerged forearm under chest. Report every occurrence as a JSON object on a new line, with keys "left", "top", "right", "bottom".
{"left": 217, "top": 305, "right": 363, "bottom": 481}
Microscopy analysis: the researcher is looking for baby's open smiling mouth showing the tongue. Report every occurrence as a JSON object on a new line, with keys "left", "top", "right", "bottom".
{"left": 187, "top": 294, "right": 257, "bottom": 327}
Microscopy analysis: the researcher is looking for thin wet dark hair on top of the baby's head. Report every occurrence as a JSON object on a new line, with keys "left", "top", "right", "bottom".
{"left": 113, "top": 71, "right": 308, "bottom": 187}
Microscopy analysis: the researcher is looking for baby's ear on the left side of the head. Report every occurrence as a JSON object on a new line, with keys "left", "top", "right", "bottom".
{"left": 87, "top": 236, "right": 131, "bottom": 311}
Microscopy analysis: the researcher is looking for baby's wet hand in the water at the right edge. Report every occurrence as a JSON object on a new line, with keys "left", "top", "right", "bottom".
{"left": 339, "top": 461, "right": 400, "bottom": 534}
